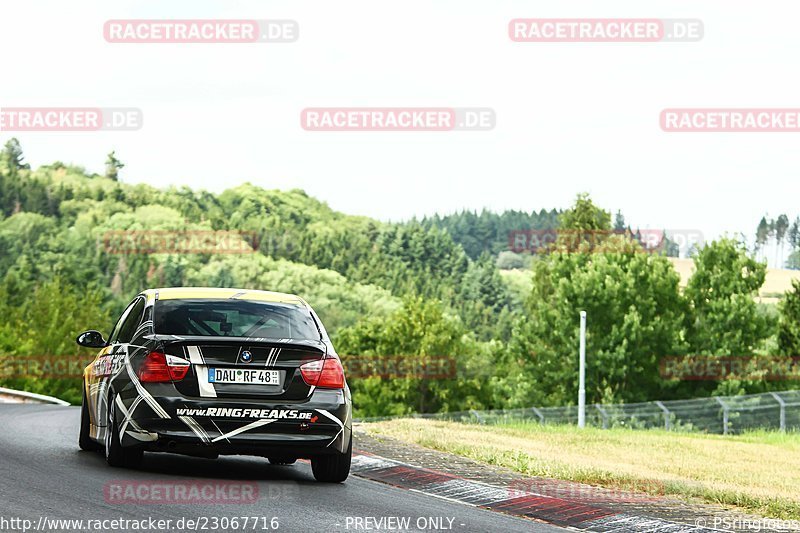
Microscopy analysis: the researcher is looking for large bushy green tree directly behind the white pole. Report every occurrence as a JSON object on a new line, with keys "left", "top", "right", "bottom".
{"left": 504, "top": 247, "right": 685, "bottom": 407}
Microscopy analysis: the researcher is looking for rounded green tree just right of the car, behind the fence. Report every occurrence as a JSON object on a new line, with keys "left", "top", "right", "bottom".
{"left": 334, "top": 298, "right": 491, "bottom": 416}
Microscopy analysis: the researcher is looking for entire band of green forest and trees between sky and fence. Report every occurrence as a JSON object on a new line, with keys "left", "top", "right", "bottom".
{"left": 0, "top": 139, "right": 800, "bottom": 416}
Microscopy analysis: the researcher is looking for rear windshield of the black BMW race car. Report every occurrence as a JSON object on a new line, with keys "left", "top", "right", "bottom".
{"left": 153, "top": 300, "right": 320, "bottom": 341}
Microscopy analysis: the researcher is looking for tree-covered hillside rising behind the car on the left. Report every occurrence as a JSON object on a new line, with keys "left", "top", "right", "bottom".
{"left": 0, "top": 154, "right": 510, "bottom": 337}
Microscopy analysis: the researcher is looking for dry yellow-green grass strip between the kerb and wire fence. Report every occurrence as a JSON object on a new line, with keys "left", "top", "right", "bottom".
{"left": 363, "top": 419, "right": 800, "bottom": 519}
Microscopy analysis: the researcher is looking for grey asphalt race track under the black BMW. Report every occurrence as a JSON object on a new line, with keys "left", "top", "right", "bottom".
{"left": 0, "top": 404, "right": 565, "bottom": 533}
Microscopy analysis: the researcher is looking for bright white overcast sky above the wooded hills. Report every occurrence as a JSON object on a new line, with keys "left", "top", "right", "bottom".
{"left": 0, "top": 0, "right": 800, "bottom": 254}
